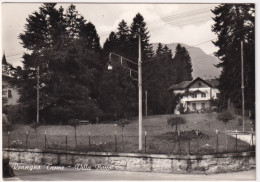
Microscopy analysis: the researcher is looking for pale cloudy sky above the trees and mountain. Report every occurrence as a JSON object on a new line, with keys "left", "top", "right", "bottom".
{"left": 2, "top": 3, "right": 217, "bottom": 66}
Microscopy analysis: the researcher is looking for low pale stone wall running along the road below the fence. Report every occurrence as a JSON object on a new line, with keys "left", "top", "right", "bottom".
{"left": 3, "top": 149, "right": 255, "bottom": 174}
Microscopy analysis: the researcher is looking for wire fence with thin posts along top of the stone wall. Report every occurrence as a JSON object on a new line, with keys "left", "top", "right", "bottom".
{"left": 3, "top": 131, "right": 255, "bottom": 155}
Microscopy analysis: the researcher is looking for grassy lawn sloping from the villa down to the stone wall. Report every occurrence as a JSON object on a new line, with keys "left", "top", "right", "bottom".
{"left": 3, "top": 113, "right": 252, "bottom": 154}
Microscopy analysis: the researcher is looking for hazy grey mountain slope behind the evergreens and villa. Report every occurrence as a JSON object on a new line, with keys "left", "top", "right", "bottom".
{"left": 152, "top": 43, "right": 220, "bottom": 79}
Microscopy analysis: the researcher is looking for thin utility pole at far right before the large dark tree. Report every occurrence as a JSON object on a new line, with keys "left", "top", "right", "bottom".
{"left": 241, "top": 40, "right": 245, "bottom": 132}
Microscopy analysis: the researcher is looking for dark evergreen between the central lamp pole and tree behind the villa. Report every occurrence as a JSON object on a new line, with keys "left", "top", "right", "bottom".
{"left": 145, "top": 43, "right": 175, "bottom": 114}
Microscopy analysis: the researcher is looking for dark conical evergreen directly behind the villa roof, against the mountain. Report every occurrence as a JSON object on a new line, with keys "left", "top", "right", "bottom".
{"left": 174, "top": 44, "right": 193, "bottom": 83}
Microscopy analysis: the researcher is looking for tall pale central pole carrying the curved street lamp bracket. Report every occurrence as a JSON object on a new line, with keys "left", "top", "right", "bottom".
{"left": 138, "top": 29, "right": 143, "bottom": 152}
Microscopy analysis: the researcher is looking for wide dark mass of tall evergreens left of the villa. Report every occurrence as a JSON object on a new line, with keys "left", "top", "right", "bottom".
{"left": 8, "top": 3, "right": 192, "bottom": 124}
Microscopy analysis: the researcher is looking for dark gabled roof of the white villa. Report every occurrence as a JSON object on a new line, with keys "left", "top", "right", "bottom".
{"left": 168, "top": 77, "right": 219, "bottom": 90}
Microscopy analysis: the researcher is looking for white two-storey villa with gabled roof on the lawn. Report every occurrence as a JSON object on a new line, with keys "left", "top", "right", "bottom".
{"left": 168, "top": 77, "right": 219, "bottom": 114}
